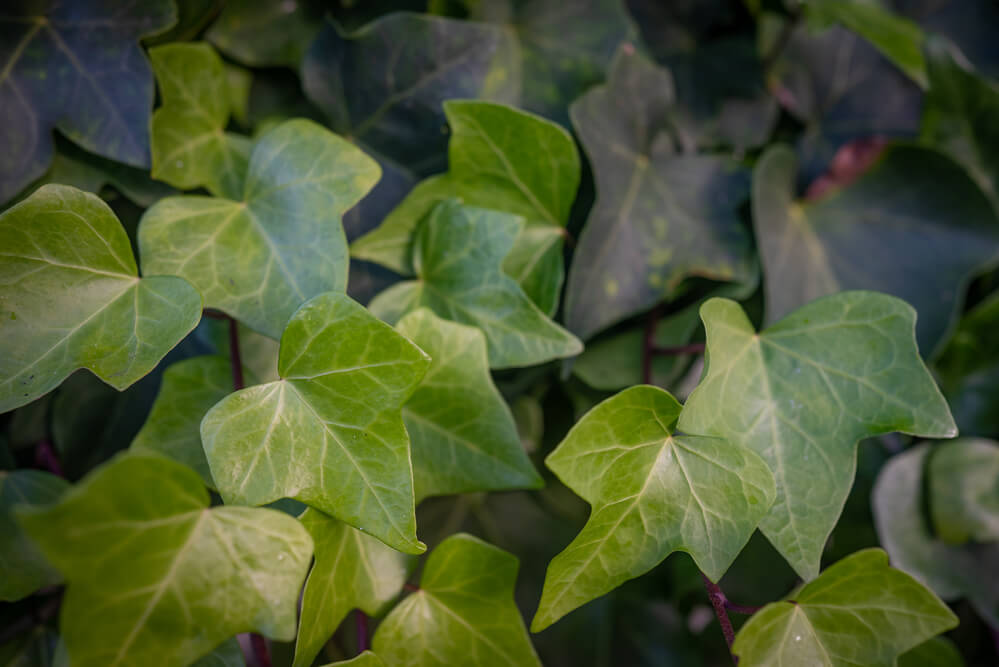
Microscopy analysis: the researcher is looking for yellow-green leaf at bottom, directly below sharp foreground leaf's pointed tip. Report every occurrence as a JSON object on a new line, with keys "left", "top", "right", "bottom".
{"left": 294, "top": 509, "right": 410, "bottom": 667}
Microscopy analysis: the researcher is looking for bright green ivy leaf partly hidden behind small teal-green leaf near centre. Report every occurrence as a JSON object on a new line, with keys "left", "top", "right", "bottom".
{"left": 351, "top": 100, "right": 580, "bottom": 315}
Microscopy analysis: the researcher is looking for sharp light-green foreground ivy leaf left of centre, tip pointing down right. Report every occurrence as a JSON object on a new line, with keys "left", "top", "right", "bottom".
{"left": 201, "top": 293, "right": 430, "bottom": 554}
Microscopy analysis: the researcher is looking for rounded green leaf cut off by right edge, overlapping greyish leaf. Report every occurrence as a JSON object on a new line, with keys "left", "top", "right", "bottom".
{"left": 927, "top": 439, "right": 999, "bottom": 544}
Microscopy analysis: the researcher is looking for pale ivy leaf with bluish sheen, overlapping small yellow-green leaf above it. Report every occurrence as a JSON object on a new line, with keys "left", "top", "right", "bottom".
{"left": 139, "top": 120, "right": 379, "bottom": 338}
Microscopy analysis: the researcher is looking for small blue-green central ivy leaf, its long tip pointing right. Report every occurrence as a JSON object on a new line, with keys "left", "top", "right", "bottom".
{"left": 371, "top": 200, "right": 582, "bottom": 368}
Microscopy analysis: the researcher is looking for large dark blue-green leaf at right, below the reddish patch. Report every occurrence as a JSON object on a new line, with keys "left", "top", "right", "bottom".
{"left": 753, "top": 146, "right": 999, "bottom": 355}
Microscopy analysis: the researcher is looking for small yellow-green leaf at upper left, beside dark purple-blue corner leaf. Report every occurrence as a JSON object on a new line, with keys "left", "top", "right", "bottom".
{"left": 149, "top": 44, "right": 251, "bottom": 199}
